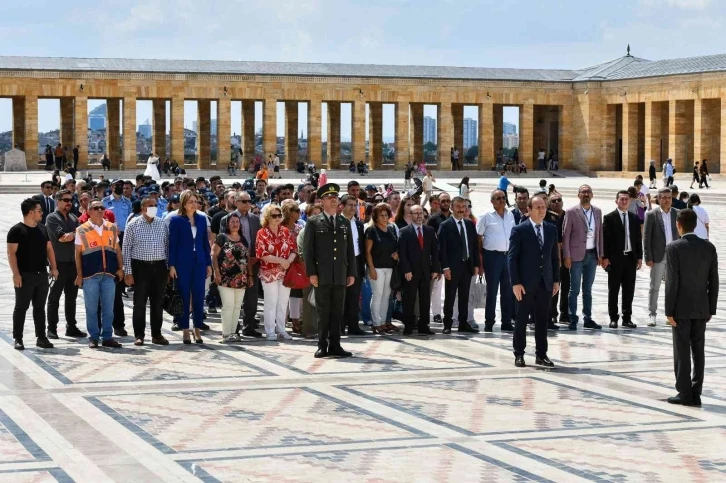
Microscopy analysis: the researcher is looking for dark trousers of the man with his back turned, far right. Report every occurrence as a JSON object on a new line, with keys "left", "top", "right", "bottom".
{"left": 672, "top": 319, "right": 706, "bottom": 402}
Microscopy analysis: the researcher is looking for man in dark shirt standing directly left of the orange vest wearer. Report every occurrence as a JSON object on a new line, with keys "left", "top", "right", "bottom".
{"left": 45, "top": 189, "right": 86, "bottom": 339}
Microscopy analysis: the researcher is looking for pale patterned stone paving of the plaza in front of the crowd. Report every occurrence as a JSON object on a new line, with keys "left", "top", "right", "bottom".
{"left": 0, "top": 186, "right": 726, "bottom": 482}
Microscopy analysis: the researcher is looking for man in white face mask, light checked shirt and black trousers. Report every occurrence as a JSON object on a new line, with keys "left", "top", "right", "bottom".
{"left": 122, "top": 197, "right": 169, "bottom": 346}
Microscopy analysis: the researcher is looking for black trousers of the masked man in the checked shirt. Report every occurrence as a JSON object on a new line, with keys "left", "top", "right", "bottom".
{"left": 131, "top": 260, "right": 167, "bottom": 339}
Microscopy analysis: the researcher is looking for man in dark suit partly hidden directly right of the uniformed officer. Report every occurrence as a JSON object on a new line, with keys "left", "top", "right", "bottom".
{"left": 340, "top": 194, "right": 368, "bottom": 335}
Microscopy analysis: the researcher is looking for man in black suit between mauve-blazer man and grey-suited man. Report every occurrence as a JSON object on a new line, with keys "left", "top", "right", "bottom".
{"left": 602, "top": 190, "right": 643, "bottom": 329}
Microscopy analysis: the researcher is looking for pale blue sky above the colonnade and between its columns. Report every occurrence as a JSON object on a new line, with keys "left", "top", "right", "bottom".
{"left": 0, "top": 0, "right": 726, "bottom": 138}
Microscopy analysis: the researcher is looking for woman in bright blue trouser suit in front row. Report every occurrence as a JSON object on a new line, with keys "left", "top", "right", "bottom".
{"left": 169, "top": 191, "right": 212, "bottom": 344}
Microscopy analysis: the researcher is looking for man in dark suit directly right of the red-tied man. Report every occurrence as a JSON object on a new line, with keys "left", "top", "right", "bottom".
{"left": 438, "top": 196, "right": 481, "bottom": 334}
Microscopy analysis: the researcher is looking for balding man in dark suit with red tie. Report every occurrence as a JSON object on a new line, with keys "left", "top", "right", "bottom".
{"left": 398, "top": 205, "right": 441, "bottom": 335}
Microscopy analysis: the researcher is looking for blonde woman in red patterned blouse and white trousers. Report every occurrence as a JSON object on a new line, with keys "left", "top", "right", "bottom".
{"left": 256, "top": 203, "right": 297, "bottom": 340}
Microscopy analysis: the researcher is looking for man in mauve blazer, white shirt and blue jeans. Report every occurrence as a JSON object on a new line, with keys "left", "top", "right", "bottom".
{"left": 562, "top": 184, "right": 603, "bottom": 330}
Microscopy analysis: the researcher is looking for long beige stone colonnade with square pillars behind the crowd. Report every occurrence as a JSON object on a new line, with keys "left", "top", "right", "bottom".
{"left": 0, "top": 55, "right": 726, "bottom": 172}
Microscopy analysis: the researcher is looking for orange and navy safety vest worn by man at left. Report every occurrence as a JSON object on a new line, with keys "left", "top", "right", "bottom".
{"left": 76, "top": 220, "right": 121, "bottom": 278}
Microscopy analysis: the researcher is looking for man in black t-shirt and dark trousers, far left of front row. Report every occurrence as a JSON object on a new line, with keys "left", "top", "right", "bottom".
{"left": 7, "top": 198, "right": 59, "bottom": 350}
